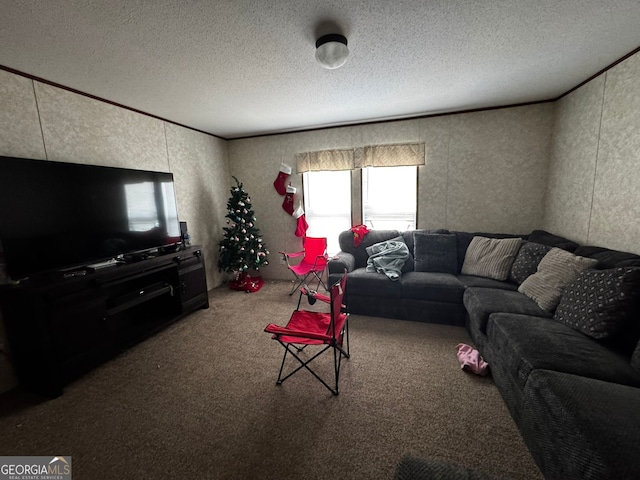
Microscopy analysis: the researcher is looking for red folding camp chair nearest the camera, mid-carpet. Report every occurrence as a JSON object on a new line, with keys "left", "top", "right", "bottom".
{"left": 264, "top": 271, "right": 349, "bottom": 395}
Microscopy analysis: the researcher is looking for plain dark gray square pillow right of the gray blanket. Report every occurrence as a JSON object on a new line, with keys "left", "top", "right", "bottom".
{"left": 413, "top": 232, "right": 458, "bottom": 275}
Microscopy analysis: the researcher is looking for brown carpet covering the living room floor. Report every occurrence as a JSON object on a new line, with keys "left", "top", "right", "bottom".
{"left": 0, "top": 282, "right": 541, "bottom": 480}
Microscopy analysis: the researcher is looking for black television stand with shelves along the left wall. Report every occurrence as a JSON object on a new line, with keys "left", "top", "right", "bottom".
{"left": 0, "top": 246, "right": 209, "bottom": 397}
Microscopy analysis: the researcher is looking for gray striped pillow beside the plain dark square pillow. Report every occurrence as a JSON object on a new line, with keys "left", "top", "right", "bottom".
{"left": 462, "top": 237, "right": 522, "bottom": 280}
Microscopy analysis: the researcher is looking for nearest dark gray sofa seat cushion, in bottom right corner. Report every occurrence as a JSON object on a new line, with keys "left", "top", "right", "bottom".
{"left": 518, "top": 370, "right": 640, "bottom": 479}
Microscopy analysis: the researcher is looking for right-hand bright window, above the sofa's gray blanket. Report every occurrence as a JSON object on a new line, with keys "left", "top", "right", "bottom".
{"left": 362, "top": 166, "right": 418, "bottom": 231}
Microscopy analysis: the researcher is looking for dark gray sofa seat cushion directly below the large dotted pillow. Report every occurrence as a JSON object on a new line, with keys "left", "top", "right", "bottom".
{"left": 487, "top": 313, "right": 640, "bottom": 389}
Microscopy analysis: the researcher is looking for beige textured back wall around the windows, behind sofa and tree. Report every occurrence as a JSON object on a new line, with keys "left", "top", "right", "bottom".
{"left": 229, "top": 104, "right": 553, "bottom": 278}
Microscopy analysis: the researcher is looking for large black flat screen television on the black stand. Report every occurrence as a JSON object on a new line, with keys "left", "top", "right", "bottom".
{"left": 0, "top": 156, "right": 180, "bottom": 280}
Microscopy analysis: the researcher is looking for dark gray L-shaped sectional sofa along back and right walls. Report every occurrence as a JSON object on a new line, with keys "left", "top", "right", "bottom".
{"left": 329, "top": 230, "right": 640, "bottom": 479}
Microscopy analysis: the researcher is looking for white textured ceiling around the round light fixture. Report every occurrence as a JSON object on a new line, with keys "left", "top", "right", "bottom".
{"left": 0, "top": 0, "right": 640, "bottom": 138}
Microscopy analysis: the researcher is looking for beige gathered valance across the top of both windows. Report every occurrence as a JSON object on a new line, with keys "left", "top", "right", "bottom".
{"left": 296, "top": 143, "right": 425, "bottom": 173}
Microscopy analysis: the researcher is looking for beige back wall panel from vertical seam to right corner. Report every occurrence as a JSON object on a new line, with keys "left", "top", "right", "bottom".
{"left": 446, "top": 104, "right": 553, "bottom": 233}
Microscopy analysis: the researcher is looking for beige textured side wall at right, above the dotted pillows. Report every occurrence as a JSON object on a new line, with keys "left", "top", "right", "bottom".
{"left": 544, "top": 50, "right": 640, "bottom": 253}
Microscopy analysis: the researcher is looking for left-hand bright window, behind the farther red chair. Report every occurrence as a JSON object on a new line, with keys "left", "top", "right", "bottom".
{"left": 303, "top": 170, "right": 351, "bottom": 255}
